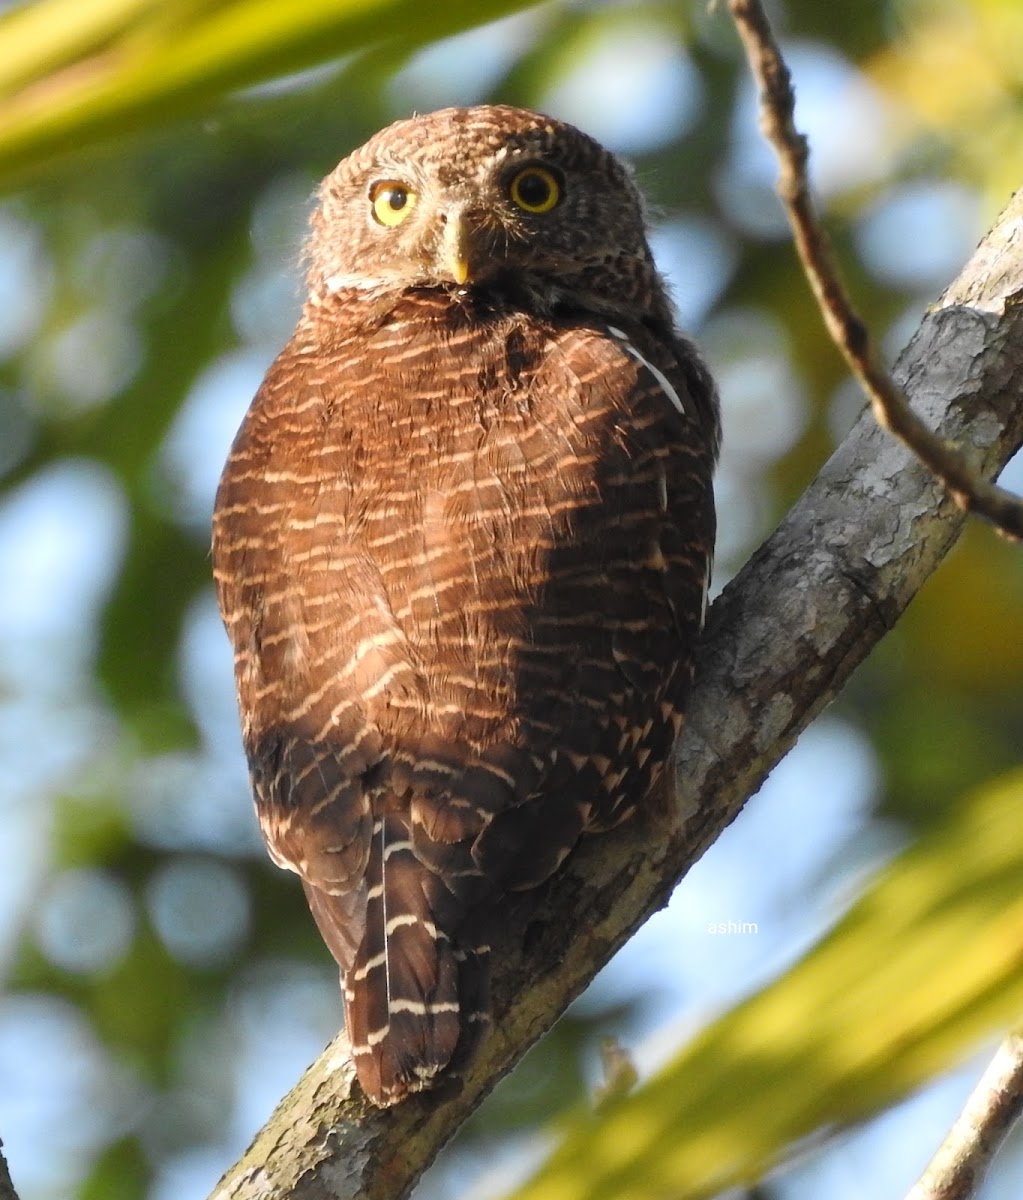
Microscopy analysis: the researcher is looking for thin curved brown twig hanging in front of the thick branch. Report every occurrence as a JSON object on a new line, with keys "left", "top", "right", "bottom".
{"left": 729, "top": 0, "right": 1023, "bottom": 540}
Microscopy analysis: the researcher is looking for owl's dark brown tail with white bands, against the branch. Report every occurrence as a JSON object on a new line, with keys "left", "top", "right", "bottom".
{"left": 343, "top": 814, "right": 490, "bottom": 1106}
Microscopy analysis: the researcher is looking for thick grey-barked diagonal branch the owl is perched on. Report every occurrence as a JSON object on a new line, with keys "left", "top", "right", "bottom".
{"left": 214, "top": 180, "right": 1023, "bottom": 1200}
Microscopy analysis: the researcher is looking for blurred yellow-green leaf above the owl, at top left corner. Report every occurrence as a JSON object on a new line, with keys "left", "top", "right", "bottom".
{"left": 0, "top": 0, "right": 537, "bottom": 185}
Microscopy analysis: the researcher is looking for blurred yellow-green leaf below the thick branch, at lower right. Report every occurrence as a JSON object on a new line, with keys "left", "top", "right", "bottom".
{"left": 516, "top": 770, "right": 1023, "bottom": 1200}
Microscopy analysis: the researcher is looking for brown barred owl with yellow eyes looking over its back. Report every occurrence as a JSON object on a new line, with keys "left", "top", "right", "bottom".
{"left": 213, "top": 106, "right": 719, "bottom": 1106}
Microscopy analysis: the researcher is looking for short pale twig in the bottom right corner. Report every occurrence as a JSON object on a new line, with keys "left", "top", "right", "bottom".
{"left": 905, "top": 1028, "right": 1023, "bottom": 1200}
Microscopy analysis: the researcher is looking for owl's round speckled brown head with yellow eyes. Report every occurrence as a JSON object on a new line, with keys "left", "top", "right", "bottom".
{"left": 309, "top": 106, "right": 666, "bottom": 324}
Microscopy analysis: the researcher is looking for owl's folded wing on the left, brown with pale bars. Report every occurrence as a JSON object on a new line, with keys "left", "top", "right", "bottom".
{"left": 213, "top": 347, "right": 384, "bottom": 970}
